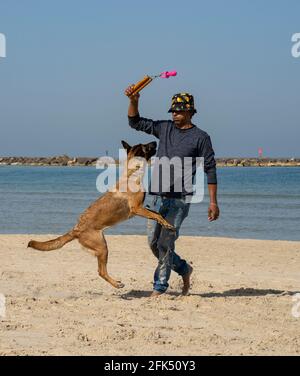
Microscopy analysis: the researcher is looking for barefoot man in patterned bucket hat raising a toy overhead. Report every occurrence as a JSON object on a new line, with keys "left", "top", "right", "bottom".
{"left": 125, "top": 85, "right": 219, "bottom": 297}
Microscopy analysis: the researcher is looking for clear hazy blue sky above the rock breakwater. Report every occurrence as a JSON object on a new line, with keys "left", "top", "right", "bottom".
{"left": 0, "top": 0, "right": 300, "bottom": 157}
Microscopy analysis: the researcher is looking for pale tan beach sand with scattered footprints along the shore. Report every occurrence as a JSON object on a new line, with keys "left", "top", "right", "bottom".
{"left": 0, "top": 235, "right": 300, "bottom": 355}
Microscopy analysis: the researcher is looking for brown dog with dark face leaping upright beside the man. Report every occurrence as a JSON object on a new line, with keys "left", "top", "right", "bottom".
{"left": 28, "top": 141, "right": 174, "bottom": 288}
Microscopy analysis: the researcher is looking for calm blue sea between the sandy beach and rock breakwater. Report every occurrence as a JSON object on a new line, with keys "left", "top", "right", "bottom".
{"left": 0, "top": 166, "right": 300, "bottom": 241}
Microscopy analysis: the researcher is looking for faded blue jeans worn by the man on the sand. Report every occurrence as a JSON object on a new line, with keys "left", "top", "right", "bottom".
{"left": 147, "top": 196, "right": 190, "bottom": 292}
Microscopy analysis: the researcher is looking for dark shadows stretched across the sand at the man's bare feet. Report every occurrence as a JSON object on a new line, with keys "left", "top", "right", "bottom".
{"left": 120, "top": 287, "right": 299, "bottom": 300}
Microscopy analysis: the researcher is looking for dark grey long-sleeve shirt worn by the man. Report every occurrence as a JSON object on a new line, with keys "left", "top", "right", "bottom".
{"left": 129, "top": 115, "right": 217, "bottom": 197}
